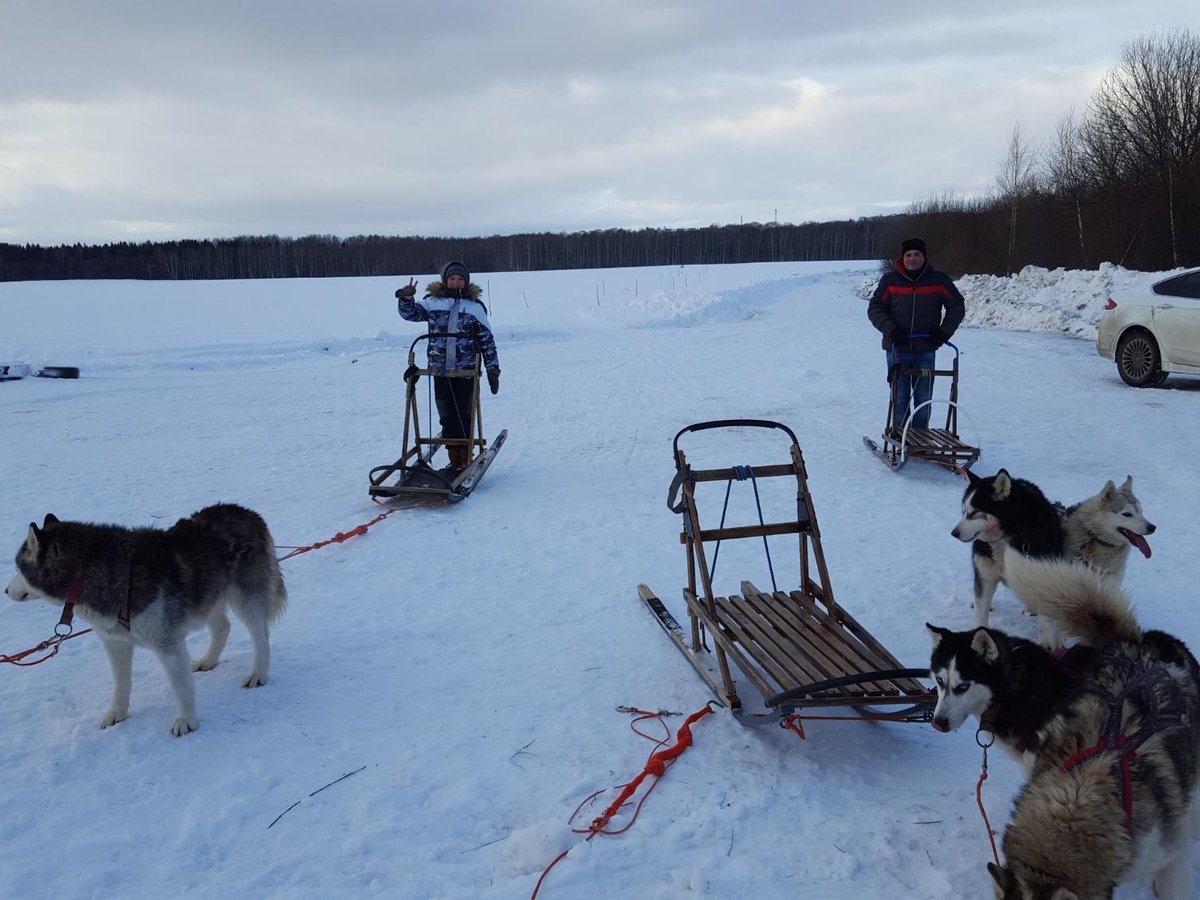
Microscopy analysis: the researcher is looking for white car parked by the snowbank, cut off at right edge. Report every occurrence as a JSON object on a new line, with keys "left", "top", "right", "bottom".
{"left": 1096, "top": 269, "right": 1200, "bottom": 388}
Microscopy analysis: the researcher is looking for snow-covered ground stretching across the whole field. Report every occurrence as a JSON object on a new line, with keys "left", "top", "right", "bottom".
{"left": 0, "top": 262, "right": 1200, "bottom": 900}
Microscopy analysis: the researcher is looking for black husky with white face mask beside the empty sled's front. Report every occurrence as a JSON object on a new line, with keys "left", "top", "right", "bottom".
{"left": 925, "top": 623, "right": 1096, "bottom": 769}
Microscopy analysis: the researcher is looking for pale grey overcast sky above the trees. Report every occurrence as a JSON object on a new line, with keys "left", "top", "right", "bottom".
{"left": 0, "top": 0, "right": 1200, "bottom": 245}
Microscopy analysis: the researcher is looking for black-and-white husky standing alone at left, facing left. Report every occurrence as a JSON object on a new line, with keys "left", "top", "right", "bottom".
{"left": 6, "top": 504, "right": 287, "bottom": 736}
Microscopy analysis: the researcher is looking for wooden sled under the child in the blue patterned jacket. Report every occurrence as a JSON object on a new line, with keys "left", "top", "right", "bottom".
{"left": 367, "top": 332, "right": 509, "bottom": 506}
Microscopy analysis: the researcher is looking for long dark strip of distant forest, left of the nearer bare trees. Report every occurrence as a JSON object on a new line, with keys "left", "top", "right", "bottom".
{"left": 0, "top": 217, "right": 889, "bottom": 281}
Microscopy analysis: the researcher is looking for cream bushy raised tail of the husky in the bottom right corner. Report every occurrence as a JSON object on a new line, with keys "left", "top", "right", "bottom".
{"left": 1004, "top": 547, "right": 1141, "bottom": 647}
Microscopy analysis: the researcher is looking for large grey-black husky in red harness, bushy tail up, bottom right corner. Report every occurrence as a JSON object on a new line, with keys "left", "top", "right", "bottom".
{"left": 988, "top": 551, "right": 1200, "bottom": 900}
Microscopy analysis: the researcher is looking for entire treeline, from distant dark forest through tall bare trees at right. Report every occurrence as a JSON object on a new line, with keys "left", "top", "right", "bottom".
{"left": 0, "top": 30, "right": 1200, "bottom": 281}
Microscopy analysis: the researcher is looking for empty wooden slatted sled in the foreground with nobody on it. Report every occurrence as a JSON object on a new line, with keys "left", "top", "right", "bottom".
{"left": 637, "top": 419, "right": 937, "bottom": 725}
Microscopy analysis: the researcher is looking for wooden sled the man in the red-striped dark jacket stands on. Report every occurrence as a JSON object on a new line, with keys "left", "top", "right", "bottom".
{"left": 863, "top": 335, "right": 980, "bottom": 470}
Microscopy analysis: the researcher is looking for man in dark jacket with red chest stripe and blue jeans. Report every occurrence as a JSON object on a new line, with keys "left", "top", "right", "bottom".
{"left": 866, "top": 238, "right": 966, "bottom": 428}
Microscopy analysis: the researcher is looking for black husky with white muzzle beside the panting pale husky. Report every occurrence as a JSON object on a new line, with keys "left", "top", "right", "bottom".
{"left": 950, "top": 469, "right": 1064, "bottom": 626}
